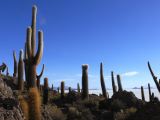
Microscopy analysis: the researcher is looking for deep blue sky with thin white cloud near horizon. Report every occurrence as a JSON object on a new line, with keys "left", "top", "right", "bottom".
{"left": 0, "top": 0, "right": 160, "bottom": 88}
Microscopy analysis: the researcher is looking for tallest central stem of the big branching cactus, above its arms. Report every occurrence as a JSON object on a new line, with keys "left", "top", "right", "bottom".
{"left": 31, "top": 5, "right": 37, "bottom": 56}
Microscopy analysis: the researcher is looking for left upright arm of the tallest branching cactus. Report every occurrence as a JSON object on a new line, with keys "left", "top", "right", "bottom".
{"left": 27, "top": 27, "right": 32, "bottom": 58}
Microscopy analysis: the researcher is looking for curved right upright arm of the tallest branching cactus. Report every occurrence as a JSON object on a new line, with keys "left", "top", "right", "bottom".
{"left": 35, "top": 31, "right": 43, "bottom": 65}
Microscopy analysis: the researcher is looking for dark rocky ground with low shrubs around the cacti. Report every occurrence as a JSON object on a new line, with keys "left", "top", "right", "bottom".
{"left": 0, "top": 76, "right": 160, "bottom": 120}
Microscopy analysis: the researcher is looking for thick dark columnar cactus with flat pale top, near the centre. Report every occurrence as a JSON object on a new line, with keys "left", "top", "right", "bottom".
{"left": 82, "top": 65, "right": 89, "bottom": 99}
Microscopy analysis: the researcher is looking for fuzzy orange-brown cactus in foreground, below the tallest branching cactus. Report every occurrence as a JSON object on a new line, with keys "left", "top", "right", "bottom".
{"left": 28, "top": 88, "right": 41, "bottom": 120}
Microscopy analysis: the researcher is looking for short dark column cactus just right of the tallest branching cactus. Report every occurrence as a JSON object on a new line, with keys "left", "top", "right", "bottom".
{"left": 43, "top": 78, "right": 49, "bottom": 105}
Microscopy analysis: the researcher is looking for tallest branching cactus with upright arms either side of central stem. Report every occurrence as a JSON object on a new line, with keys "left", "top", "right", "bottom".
{"left": 27, "top": 6, "right": 43, "bottom": 87}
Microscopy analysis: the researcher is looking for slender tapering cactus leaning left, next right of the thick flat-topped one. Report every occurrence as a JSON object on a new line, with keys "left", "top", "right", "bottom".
{"left": 100, "top": 63, "right": 107, "bottom": 98}
